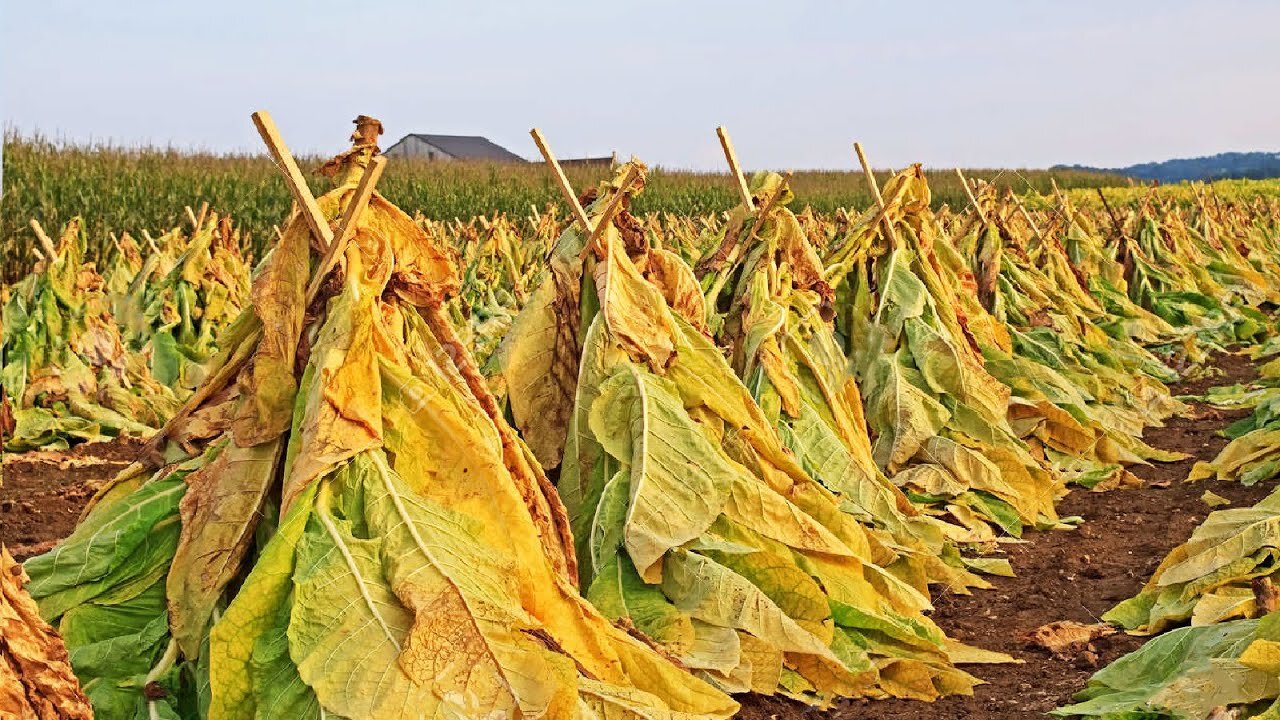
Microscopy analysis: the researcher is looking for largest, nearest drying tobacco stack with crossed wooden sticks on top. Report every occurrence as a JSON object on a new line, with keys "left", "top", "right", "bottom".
{"left": 27, "top": 118, "right": 736, "bottom": 719}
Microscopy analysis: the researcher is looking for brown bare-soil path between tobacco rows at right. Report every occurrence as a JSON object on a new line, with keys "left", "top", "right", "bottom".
{"left": 740, "top": 356, "right": 1272, "bottom": 720}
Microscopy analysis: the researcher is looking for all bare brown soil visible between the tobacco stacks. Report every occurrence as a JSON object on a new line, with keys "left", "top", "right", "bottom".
{"left": 0, "top": 356, "right": 1271, "bottom": 720}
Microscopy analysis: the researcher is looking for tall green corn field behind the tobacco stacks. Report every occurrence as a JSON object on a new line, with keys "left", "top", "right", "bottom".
{"left": 0, "top": 133, "right": 1128, "bottom": 282}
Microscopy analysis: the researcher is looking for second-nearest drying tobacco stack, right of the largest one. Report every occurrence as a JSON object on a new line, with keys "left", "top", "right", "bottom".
{"left": 499, "top": 163, "right": 998, "bottom": 703}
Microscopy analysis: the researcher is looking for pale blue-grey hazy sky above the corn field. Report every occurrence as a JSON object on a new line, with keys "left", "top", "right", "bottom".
{"left": 0, "top": 0, "right": 1280, "bottom": 170}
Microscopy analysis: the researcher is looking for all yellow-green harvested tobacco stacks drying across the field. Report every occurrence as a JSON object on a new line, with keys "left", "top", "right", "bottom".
{"left": 0, "top": 119, "right": 1280, "bottom": 720}
